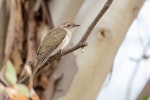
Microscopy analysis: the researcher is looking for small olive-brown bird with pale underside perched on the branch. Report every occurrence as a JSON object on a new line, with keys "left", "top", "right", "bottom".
{"left": 33, "top": 22, "right": 80, "bottom": 75}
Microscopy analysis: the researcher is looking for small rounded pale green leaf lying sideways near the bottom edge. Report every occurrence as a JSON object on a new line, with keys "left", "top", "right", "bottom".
{"left": 15, "top": 84, "right": 30, "bottom": 97}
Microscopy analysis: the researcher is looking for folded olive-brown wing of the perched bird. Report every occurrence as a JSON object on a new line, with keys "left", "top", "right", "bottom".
{"left": 37, "top": 28, "right": 67, "bottom": 59}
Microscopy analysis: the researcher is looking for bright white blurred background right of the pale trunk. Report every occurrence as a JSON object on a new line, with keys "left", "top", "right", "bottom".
{"left": 97, "top": 0, "right": 150, "bottom": 100}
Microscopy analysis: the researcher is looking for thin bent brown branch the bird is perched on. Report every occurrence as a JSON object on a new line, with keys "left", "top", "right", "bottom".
{"left": 20, "top": 0, "right": 113, "bottom": 82}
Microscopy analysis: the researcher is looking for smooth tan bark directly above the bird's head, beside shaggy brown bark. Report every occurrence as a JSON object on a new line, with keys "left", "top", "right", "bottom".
{"left": 50, "top": 0, "right": 84, "bottom": 25}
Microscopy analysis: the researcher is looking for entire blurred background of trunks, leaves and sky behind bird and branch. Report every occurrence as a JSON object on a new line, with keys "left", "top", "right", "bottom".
{"left": 0, "top": 0, "right": 150, "bottom": 100}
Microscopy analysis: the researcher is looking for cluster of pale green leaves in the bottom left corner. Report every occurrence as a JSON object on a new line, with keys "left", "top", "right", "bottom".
{"left": 0, "top": 61, "right": 30, "bottom": 97}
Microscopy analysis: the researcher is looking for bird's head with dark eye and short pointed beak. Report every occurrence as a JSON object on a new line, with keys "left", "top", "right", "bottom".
{"left": 60, "top": 22, "right": 80, "bottom": 33}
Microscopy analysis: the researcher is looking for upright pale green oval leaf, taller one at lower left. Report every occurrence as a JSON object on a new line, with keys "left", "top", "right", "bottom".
{"left": 5, "top": 61, "right": 17, "bottom": 85}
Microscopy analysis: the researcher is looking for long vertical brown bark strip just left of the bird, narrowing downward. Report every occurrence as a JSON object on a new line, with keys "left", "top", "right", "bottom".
{"left": 19, "top": 1, "right": 36, "bottom": 77}
